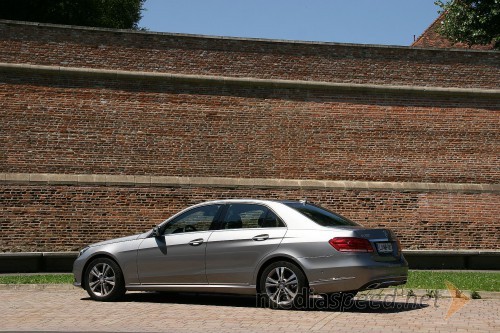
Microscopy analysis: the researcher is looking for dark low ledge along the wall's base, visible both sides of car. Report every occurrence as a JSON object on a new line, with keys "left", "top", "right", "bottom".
{"left": 0, "top": 250, "right": 500, "bottom": 273}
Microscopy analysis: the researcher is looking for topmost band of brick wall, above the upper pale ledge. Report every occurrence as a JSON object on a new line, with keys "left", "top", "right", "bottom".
{"left": 0, "top": 21, "right": 500, "bottom": 89}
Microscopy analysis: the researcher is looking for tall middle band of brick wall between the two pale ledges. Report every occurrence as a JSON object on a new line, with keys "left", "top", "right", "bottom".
{"left": 0, "top": 72, "right": 500, "bottom": 183}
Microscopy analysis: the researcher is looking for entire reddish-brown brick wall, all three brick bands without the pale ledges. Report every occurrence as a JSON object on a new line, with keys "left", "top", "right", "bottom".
{"left": 0, "top": 21, "right": 500, "bottom": 251}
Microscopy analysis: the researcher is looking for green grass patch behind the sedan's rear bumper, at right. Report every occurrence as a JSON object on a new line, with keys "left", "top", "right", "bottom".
{"left": 405, "top": 270, "right": 500, "bottom": 291}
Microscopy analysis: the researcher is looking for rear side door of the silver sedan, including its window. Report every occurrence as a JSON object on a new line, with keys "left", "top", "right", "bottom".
{"left": 207, "top": 204, "right": 287, "bottom": 285}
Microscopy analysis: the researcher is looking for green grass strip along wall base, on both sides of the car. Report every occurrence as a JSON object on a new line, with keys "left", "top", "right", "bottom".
{"left": 0, "top": 270, "right": 500, "bottom": 291}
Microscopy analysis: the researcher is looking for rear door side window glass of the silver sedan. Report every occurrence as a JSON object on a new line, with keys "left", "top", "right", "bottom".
{"left": 221, "top": 204, "right": 285, "bottom": 229}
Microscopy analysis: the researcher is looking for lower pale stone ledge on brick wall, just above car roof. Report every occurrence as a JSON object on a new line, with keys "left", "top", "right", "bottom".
{"left": 0, "top": 173, "right": 500, "bottom": 193}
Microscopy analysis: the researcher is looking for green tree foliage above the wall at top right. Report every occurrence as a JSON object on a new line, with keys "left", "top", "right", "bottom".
{"left": 435, "top": 0, "right": 500, "bottom": 49}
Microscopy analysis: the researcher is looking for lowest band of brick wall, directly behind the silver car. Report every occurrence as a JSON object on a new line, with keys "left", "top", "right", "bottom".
{"left": 0, "top": 185, "right": 500, "bottom": 251}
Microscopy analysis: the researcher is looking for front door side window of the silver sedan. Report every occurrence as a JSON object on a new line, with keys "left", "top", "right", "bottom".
{"left": 163, "top": 205, "right": 221, "bottom": 235}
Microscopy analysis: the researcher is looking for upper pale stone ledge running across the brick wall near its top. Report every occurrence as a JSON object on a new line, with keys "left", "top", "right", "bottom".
{"left": 0, "top": 63, "right": 500, "bottom": 98}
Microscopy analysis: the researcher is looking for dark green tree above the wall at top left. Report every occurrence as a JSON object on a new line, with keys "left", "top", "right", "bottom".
{"left": 0, "top": 0, "right": 145, "bottom": 30}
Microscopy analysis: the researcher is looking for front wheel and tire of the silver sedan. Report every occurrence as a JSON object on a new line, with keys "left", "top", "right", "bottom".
{"left": 84, "top": 258, "right": 125, "bottom": 302}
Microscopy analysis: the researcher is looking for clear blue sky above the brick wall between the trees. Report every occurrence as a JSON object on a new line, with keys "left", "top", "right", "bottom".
{"left": 139, "top": 0, "right": 439, "bottom": 46}
